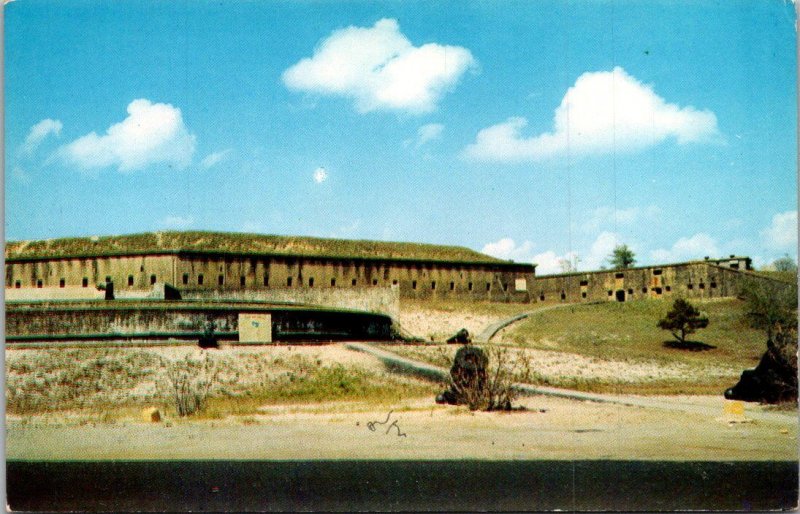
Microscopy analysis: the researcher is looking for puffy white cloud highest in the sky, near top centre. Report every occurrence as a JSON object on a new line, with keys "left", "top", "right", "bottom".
{"left": 282, "top": 19, "right": 475, "bottom": 113}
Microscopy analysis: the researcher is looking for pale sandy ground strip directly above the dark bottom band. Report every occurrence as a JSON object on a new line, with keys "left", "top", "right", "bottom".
{"left": 6, "top": 397, "right": 798, "bottom": 460}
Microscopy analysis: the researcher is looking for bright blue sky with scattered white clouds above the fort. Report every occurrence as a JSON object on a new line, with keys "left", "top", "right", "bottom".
{"left": 5, "top": 0, "right": 797, "bottom": 273}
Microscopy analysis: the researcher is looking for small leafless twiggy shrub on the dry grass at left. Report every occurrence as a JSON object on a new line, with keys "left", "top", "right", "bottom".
{"left": 163, "top": 352, "right": 219, "bottom": 417}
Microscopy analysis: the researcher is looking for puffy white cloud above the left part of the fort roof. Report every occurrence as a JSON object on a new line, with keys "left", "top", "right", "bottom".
{"left": 59, "top": 99, "right": 196, "bottom": 172}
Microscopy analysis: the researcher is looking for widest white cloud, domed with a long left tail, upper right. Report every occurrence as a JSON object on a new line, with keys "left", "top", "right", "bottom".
{"left": 463, "top": 67, "right": 719, "bottom": 162}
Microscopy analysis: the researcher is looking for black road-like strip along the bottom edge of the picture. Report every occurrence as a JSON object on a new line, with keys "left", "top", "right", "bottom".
{"left": 7, "top": 460, "right": 798, "bottom": 512}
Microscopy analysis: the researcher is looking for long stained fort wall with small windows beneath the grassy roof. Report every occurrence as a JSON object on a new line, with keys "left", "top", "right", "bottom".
{"left": 6, "top": 254, "right": 534, "bottom": 302}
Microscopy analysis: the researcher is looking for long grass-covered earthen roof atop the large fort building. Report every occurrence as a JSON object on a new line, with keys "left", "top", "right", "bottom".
{"left": 6, "top": 231, "right": 504, "bottom": 262}
